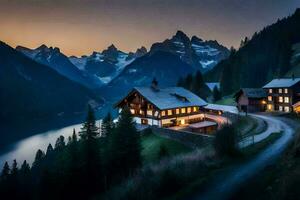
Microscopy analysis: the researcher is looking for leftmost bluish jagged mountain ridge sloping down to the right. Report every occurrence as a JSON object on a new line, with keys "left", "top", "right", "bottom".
{"left": 16, "top": 45, "right": 103, "bottom": 89}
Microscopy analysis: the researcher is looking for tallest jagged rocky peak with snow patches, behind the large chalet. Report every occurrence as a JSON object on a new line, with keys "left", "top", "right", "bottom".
{"left": 150, "top": 31, "right": 229, "bottom": 72}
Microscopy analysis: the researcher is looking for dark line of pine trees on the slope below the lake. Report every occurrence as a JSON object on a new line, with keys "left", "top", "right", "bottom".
{"left": 0, "top": 106, "right": 142, "bottom": 199}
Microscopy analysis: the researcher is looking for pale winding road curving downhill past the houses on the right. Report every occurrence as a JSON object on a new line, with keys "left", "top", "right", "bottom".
{"left": 189, "top": 115, "right": 294, "bottom": 200}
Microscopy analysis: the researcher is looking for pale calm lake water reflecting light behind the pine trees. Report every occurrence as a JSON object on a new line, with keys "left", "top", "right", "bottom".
{"left": 0, "top": 120, "right": 101, "bottom": 169}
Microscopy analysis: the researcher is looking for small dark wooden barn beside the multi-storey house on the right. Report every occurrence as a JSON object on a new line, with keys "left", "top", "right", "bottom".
{"left": 234, "top": 88, "right": 267, "bottom": 113}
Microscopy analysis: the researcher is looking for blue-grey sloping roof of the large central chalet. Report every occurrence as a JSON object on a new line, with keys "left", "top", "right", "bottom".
{"left": 134, "top": 87, "right": 207, "bottom": 110}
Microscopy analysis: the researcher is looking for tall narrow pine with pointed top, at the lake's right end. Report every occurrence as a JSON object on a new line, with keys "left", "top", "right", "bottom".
{"left": 79, "top": 105, "right": 99, "bottom": 140}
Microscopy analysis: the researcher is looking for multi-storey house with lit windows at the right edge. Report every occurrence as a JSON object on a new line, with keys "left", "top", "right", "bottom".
{"left": 263, "top": 78, "right": 300, "bottom": 112}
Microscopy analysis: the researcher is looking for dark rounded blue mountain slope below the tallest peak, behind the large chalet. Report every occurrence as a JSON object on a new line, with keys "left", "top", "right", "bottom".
{"left": 102, "top": 51, "right": 195, "bottom": 101}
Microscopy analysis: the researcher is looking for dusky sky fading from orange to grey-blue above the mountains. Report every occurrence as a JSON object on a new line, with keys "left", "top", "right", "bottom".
{"left": 0, "top": 0, "right": 300, "bottom": 56}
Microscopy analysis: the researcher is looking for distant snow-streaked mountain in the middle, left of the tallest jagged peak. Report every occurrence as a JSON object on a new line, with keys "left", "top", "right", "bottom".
{"left": 69, "top": 44, "right": 147, "bottom": 83}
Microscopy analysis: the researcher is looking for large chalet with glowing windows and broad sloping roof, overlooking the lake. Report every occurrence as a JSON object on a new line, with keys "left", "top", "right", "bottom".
{"left": 116, "top": 84, "right": 207, "bottom": 127}
